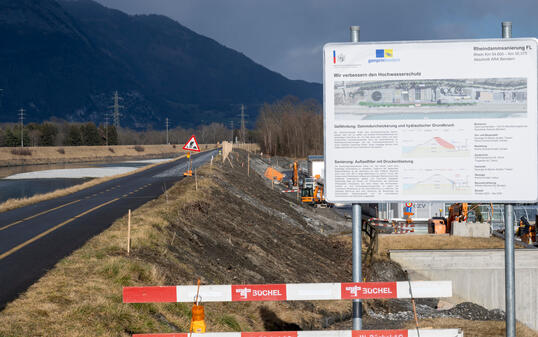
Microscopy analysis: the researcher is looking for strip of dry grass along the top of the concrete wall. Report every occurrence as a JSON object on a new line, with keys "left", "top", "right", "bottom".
{"left": 378, "top": 235, "right": 504, "bottom": 256}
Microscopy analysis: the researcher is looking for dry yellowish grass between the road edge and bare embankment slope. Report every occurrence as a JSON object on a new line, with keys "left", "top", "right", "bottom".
{"left": 0, "top": 165, "right": 218, "bottom": 337}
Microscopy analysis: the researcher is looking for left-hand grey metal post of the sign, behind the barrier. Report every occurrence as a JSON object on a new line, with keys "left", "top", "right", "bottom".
{"left": 349, "top": 26, "right": 362, "bottom": 330}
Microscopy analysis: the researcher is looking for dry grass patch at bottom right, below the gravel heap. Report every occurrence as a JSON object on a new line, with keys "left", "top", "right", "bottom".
{"left": 406, "top": 318, "right": 538, "bottom": 337}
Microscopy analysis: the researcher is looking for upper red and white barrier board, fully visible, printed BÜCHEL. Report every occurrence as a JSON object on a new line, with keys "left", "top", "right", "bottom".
{"left": 123, "top": 281, "right": 452, "bottom": 303}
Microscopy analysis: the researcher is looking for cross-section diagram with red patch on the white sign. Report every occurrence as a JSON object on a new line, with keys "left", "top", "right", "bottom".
{"left": 402, "top": 136, "right": 471, "bottom": 158}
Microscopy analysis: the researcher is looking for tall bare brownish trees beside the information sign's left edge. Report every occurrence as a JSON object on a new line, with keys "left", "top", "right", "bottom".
{"left": 257, "top": 96, "right": 323, "bottom": 157}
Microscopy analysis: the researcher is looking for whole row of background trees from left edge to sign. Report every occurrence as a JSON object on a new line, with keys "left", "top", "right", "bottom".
{"left": 0, "top": 96, "right": 323, "bottom": 152}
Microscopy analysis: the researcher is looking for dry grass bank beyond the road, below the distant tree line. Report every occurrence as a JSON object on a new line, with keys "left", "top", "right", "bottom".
{"left": 0, "top": 144, "right": 215, "bottom": 166}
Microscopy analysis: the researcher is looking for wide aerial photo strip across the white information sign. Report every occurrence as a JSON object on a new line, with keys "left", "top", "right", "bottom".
{"left": 334, "top": 78, "right": 527, "bottom": 120}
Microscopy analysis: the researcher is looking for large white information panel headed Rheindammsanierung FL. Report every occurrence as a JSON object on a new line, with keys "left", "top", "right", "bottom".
{"left": 324, "top": 39, "right": 538, "bottom": 203}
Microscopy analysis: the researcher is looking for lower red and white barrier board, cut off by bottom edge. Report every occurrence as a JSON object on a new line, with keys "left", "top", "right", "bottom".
{"left": 133, "top": 329, "right": 463, "bottom": 337}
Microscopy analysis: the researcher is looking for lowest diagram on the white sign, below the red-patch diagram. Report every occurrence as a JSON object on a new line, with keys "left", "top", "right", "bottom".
{"left": 402, "top": 169, "right": 472, "bottom": 195}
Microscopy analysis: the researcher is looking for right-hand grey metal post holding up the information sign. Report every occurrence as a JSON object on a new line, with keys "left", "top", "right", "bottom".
{"left": 502, "top": 21, "right": 516, "bottom": 337}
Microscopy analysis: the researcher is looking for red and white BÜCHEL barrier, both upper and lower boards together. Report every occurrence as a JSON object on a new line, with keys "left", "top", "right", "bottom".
{"left": 123, "top": 281, "right": 454, "bottom": 337}
